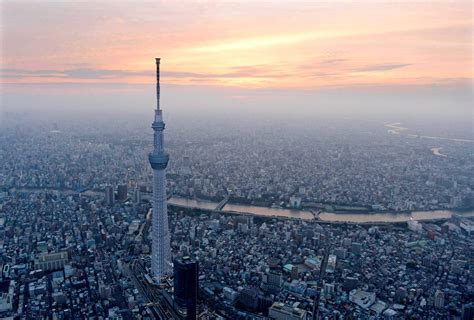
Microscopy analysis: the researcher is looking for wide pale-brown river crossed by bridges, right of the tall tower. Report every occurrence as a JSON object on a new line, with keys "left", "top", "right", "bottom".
{"left": 168, "top": 197, "right": 474, "bottom": 223}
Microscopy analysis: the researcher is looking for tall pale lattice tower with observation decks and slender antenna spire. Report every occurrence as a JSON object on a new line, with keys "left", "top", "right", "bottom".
{"left": 148, "top": 58, "right": 171, "bottom": 280}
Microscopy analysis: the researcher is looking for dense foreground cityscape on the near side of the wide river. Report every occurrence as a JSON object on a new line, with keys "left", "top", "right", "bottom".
{"left": 0, "top": 184, "right": 474, "bottom": 319}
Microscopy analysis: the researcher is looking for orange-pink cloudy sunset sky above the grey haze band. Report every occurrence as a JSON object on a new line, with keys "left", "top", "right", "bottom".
{"left": 1, "top": 0, "right": 473, "bottom": 89}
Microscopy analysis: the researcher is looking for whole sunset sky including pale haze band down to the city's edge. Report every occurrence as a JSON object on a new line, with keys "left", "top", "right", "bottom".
{"left": 0, "top": 1, "right": 474, "bottom": 135}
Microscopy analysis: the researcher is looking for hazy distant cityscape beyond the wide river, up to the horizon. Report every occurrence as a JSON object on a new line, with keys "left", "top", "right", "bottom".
{"left": 0, "top": 113, "right": 474, "bottom": 212}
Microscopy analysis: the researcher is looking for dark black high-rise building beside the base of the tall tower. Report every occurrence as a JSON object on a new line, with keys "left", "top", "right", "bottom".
{"left": 174, "top": 257, "right": 199, "bottom": 320}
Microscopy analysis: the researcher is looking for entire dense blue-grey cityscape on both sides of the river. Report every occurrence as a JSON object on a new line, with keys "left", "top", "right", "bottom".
{"left": 0, "top": 107, "right": 474, "bottom": 319}
